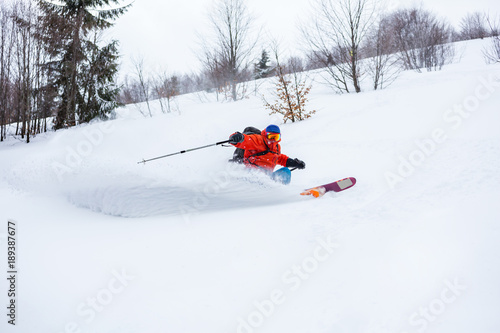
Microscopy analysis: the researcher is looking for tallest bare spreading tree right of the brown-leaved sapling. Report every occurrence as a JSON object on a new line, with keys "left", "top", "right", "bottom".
{"left": 302, "top": 0, "right": 375, "bottom": 92}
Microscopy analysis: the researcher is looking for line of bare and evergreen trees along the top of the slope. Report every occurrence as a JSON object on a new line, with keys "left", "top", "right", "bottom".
{"left": 0, "top": 0, "right": 500, "bottom": 142}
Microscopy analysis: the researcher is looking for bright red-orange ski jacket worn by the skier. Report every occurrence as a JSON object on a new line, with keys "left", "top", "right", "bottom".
{"left": 234, "top": 130, "right": 288, "bottom": 171}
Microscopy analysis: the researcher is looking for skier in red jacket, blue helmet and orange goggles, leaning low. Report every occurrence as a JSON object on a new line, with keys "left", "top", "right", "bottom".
{"left": 229, "top": 125, "right": 306, "bottom": 184}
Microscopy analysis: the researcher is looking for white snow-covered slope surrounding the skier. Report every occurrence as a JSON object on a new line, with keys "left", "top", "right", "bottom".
{"left": 0, "top": 40, "right": 500, "bottom": 333}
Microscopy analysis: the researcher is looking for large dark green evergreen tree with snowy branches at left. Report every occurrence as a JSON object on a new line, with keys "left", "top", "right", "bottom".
{"left": 38, "top": 0, "right": 128, "bottom": 129}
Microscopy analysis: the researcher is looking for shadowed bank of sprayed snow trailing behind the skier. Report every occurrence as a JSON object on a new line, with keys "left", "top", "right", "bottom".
{"left": 64, "top": 174, "right": 300, "bottom": 218}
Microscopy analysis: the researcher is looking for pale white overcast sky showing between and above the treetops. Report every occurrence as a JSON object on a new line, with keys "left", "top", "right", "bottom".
{"left": 110, "top": 0, "right": 500, "bottom": 78}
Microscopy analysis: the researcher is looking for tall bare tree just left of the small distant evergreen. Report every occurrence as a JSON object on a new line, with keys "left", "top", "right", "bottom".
{"left": 197, "top": 0, "right": 256, "bottom": 101}
